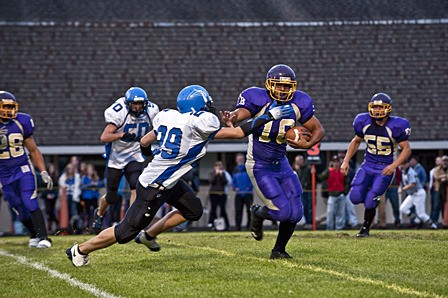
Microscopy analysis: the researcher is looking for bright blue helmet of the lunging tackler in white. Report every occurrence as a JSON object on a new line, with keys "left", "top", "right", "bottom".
{"left": 177, "top": 85, "right": 215, "bottom": 114}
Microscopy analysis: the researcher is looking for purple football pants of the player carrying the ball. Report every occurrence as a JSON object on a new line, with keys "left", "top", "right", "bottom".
{"left": 246, "top": 157, "right": 303, "bottom": 223}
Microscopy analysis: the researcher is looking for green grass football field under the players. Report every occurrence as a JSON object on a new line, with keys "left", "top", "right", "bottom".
{"left": 0, "top": 230, "right": 448, "bottom": 298}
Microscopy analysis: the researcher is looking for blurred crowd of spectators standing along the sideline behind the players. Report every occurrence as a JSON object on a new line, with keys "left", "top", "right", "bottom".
{"left": 1, "top": 152, "right": 448, "bottom": 235}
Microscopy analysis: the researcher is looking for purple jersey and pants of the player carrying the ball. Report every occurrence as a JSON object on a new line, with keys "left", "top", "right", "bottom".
{"left": 236, "top": 87, "right": 314, "bottom": 223}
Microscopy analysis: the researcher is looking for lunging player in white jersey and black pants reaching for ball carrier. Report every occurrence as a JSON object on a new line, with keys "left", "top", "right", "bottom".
{"left": 66, "top": 85, "right": 294, "bottom": 267}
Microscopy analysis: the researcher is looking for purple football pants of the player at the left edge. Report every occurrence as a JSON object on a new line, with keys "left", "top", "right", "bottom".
{"left": 2, "top": 172, "right": 39, "bottom": 220}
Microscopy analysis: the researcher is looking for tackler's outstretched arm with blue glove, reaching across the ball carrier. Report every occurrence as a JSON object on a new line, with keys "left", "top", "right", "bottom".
{"left": 215, "top": 104, "right": 294, "bottom": 139}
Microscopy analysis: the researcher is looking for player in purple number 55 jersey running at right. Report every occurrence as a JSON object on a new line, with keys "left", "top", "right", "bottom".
{"left": 341, "top": 93, "right": 411, "bottom": 237}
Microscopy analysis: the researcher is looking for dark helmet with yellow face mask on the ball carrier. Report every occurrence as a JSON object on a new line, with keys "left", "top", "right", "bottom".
{"left": 265, "top": 64, "right": 297, "bottom": 101}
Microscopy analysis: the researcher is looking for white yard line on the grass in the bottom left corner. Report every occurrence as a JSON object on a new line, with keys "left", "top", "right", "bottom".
{"left": 0, "top": 249, "right": 120, "bottom": 298}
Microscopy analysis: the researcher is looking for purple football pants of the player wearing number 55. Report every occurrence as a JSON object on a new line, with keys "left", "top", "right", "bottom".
{"left": 349, "top": 163, "right": 394, "bottom": 209}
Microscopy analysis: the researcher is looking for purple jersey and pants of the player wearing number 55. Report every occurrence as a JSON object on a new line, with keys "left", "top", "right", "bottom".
{"left": 349, "top": 113, "right": 411, "bottom": 209}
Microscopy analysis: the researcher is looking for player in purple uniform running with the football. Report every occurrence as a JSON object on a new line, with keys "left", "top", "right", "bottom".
{"left": 221, "top": 64, "right": 325, "bottom": 259}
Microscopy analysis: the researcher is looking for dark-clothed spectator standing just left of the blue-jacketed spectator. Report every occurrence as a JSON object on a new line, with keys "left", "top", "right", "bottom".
{"left": 208, "top": 160, "right": 232, "bottom": 230}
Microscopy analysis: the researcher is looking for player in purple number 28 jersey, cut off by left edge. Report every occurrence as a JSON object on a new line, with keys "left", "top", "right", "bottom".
{"left": 0, "top": 91, "right": 53, "bottom": 248}
